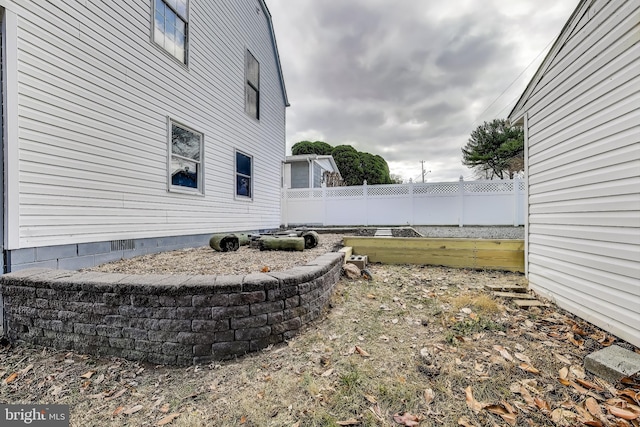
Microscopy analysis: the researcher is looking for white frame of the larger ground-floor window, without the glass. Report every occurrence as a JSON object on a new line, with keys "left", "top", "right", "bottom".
{"left": 167, "top": 117, "right": 204, "bottom": 195}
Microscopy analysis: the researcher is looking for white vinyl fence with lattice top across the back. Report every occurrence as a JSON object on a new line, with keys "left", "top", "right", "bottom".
{"left": 282, "top": 179, "right": 526, "bottom": 227}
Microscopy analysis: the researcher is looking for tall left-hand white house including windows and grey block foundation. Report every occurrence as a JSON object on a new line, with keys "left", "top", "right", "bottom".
{"left": 0, "top": 0, "right": 288, "bottom": 271}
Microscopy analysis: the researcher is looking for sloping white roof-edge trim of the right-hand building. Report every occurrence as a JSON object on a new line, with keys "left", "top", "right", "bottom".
{"left": 508, "top": 0, "right": 596, "bottom": 125}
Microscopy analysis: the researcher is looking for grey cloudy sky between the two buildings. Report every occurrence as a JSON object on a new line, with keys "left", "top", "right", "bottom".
{"left": 266, "top": 0, "right": 578, "bottom": 182}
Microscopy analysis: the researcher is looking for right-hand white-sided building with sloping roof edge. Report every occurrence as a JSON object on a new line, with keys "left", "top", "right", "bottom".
{"left": 509, "top": 0, "right": 640, "bottom": 346}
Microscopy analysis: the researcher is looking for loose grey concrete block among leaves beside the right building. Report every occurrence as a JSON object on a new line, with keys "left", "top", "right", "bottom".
{"left": 584, "top": 345, "right": 640, "bottom": 383}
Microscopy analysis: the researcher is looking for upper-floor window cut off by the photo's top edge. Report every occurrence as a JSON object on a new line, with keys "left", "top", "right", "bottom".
{"left": 153, "top": 0, "right": 189, "bottom": 64}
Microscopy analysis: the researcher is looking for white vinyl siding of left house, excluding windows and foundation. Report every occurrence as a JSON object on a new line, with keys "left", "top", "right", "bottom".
{"left": 7, "top": 0, "right": 285, "bottom": 249}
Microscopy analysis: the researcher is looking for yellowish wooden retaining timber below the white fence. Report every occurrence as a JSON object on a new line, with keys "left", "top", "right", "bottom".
{"left": 343, "top": 236, "right": 524, "bottom": 273}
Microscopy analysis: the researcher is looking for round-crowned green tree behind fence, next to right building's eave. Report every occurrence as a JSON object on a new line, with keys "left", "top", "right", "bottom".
{"left": 462, "top": 119, "right": 524, "bottom": 179}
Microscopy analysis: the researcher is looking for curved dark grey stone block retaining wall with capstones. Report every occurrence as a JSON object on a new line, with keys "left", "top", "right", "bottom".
{"left": 0, "top": 252, "right": 344, "bottom": 365}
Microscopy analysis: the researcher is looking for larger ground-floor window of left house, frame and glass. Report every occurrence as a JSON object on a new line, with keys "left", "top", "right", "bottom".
{"left": 169, "top": 121, "right": 203, "bottom": 194}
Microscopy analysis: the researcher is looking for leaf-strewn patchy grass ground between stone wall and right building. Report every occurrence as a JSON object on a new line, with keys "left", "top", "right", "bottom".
{"left": 0, "top": 264, "right": 640, "bottom": 427}
